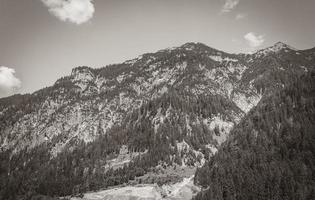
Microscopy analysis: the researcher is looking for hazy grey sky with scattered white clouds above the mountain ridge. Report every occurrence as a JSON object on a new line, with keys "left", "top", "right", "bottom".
{"left": 0, "top": 0, "right": 315, "bottom": 98}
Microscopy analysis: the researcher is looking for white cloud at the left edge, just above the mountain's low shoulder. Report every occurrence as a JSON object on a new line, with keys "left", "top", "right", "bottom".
{"left": 0, "top": 66, "right": 21, "bottom": 94}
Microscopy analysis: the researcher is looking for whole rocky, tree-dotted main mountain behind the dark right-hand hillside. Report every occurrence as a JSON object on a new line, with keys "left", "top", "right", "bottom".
{"left": 0, "top": 43, "right": 315, "bottom": 199}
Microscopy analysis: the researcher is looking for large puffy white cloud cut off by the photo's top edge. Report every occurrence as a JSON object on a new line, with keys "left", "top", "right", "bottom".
{"left": 41, "top": 0, "right": 95, "bottom": 24}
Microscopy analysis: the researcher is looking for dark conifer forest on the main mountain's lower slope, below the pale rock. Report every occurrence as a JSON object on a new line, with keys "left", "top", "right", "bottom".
{"left": 0, "top": 90, "right": 237, "bottom": 199}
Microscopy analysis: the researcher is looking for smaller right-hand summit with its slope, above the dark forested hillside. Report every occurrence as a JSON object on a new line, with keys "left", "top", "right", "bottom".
{"left": 242, "top": 42, "right": 315, "bottom": 94}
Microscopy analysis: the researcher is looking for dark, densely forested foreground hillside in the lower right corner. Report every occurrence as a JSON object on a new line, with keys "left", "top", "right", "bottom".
{"left": 195, "top": 71, "right": 315, "bottom": 199}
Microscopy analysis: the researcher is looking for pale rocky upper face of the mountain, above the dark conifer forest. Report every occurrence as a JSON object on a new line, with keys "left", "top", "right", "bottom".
{"left": 0, "top": 43, "right": 314, "bottom": 154}
